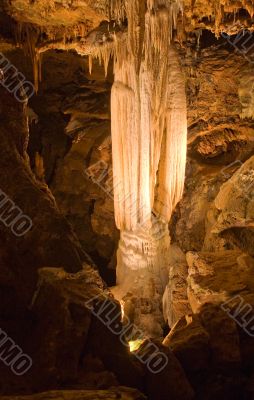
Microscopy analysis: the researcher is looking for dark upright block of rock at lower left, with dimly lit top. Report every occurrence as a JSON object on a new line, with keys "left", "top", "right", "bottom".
{"left": 30, "top": 267, "right": 103, "bottom": 387}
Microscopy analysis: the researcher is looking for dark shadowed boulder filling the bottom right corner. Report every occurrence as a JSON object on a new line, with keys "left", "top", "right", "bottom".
{"left": 164, "top": 304, "right": 248, "bottom": 399}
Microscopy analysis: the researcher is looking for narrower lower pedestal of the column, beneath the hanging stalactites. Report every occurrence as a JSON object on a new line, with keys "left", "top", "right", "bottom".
{"left": 112, "top": 221, "right": 169, "bottom": 338}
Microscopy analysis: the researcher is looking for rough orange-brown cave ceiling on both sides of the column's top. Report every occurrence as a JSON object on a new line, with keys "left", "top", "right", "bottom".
{"left": 0, "top": 0, "right": 254, "bottom": 55}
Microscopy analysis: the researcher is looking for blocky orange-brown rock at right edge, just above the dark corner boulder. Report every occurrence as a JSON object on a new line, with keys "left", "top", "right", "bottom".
{"left": 186, "top": 250, "right": 254, "bottom": 312}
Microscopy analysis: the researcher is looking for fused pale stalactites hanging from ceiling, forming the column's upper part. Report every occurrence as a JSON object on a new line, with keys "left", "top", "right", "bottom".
{"left": 111, "top": 0, "right": 186, "bottom": 230}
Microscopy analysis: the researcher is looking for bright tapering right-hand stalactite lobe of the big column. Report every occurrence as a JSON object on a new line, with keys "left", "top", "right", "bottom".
{"left": 154, "top": 47, "right": 187, "bottom": 221}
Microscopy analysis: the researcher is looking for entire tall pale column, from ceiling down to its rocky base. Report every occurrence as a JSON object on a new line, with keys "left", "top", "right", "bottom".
{"left": 111, "top": 0, "right": 187, "bottom": 336}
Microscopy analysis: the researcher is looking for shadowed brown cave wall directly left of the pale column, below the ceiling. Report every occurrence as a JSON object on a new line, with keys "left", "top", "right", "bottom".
{"left": 16, "top": 52, "right": 118, "bottom": 276}
